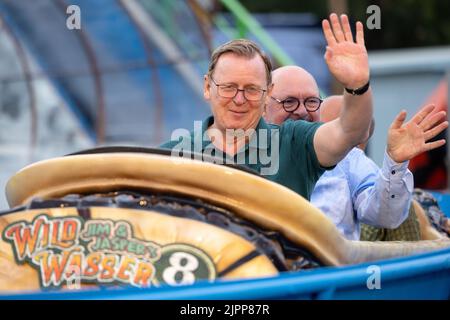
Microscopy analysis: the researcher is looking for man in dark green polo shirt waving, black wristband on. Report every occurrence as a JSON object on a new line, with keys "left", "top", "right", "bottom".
{"left": 161, "top": 14, "right": 372, "bottom": 199}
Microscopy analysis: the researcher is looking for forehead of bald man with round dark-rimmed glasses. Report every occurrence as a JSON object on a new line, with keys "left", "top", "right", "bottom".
{"left": 272, "top": 73, "right": 319, "bottom": 98}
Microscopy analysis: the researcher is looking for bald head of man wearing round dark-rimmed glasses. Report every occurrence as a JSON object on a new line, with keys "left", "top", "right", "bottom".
{"left": 264, "top": 66, "right": 319, "bottom": 124}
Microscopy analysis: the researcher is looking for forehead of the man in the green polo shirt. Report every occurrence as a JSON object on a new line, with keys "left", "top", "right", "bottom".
{"left": 213, "top": 53, "right": 266, "bottom": 86}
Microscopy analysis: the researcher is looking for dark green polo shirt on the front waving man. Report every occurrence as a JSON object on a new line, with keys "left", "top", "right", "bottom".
{"left": 160, "top": 116, "right": 325, "bottom": 200}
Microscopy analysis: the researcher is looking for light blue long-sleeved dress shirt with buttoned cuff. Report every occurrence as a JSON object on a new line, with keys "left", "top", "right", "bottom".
{"left": 311, "top": 148, "right": 414, "bottom": 240}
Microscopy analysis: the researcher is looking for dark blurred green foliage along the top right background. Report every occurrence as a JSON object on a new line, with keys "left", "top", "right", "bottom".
{"left": 241, "top": 0, "right": 450, "bottom": 49}
